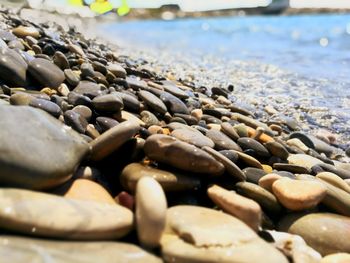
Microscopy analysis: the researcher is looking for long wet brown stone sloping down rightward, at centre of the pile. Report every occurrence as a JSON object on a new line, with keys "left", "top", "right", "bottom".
{"left": 144, "top": 134, "right": 224, "bottom": 174}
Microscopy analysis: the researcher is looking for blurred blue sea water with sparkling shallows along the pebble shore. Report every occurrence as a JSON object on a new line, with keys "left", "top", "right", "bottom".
{"left": 103, "top": 14, "right": 350, "bottom": 139}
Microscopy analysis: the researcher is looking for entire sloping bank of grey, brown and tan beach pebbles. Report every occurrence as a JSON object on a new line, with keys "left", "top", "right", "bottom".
{"left": 0, "top": 8, "right": 350, "bottom": 263}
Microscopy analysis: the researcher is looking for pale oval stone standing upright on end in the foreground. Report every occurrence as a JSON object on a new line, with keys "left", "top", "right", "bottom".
{"left": 136, "top": 176, "right": 167, "bottom": 248}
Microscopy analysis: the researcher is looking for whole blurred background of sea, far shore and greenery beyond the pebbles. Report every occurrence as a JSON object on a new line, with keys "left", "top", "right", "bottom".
{"left": 0, "top": 0, "right": 350, "bottom": 138}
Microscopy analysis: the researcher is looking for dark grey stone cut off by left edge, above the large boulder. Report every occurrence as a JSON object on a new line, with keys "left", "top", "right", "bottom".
{"left": 0, "top": 48, "right": 28, "bottom": 87}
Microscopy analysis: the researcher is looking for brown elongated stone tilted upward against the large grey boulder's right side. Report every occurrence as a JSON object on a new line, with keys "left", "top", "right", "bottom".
{"left": 90, "top": 121, "right": 140, "bottom": 161}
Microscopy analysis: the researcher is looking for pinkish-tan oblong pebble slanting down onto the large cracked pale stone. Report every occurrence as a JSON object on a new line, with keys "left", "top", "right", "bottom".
{"left": 207, "top": 185, "right": 262, "bottom": 231}
